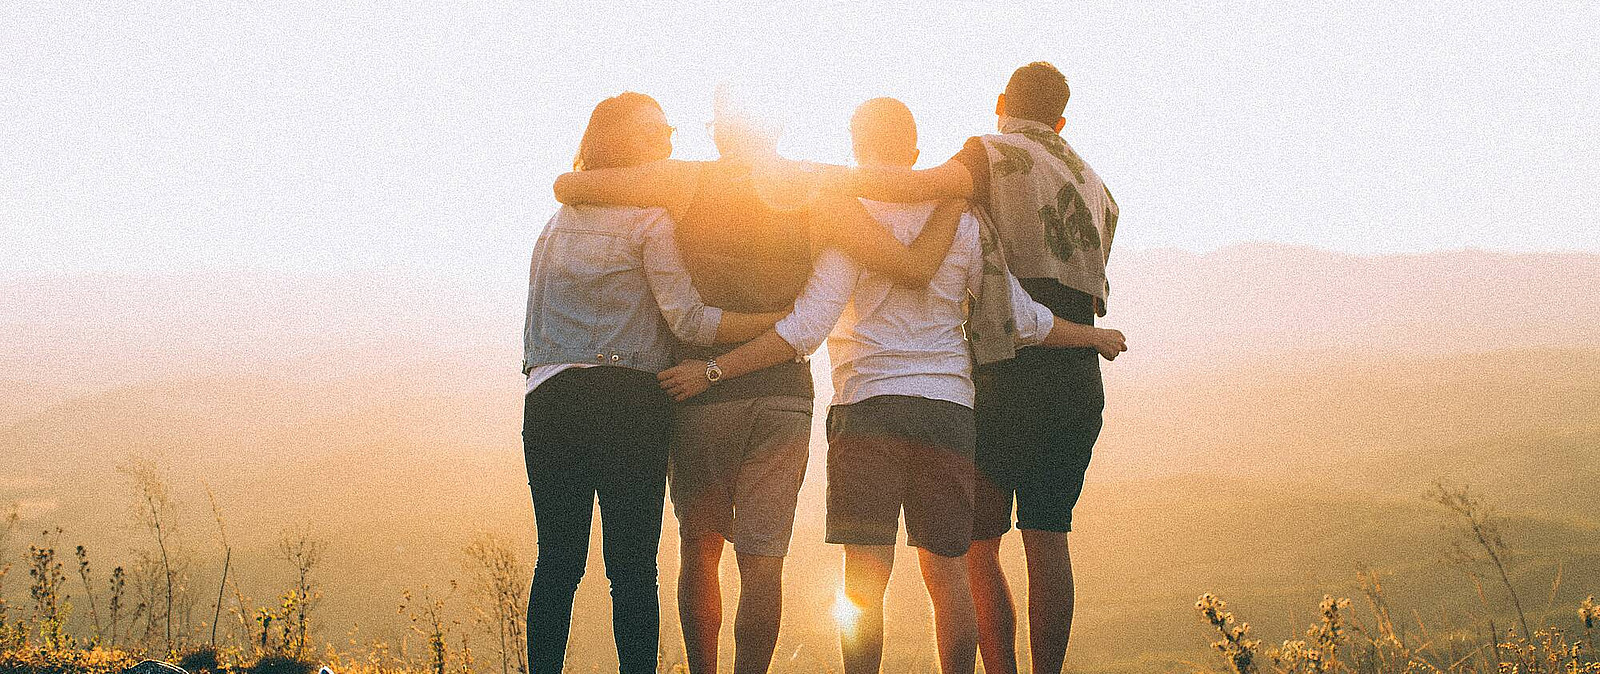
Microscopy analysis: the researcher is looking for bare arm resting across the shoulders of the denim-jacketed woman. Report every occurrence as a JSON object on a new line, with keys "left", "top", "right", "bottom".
{"left": 555, "top": 158, "right": 699, "bottom": 213}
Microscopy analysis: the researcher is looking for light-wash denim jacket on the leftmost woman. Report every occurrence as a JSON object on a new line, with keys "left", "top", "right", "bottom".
{"left": 522, "top": 207, "right": 722, "bottom": 373}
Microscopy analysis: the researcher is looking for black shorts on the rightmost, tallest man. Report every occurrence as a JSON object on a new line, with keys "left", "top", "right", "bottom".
{"left": 973, "top": 341, "right": 1106, "bottom": 541}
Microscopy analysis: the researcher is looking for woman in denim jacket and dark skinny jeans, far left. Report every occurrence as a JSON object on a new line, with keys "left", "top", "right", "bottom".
{"left": 522, "top": 93, "right": 784, "bottom": 674}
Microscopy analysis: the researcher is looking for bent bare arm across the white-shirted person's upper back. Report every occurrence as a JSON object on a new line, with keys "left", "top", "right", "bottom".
{"left": 811, "top": 195, "right": 966, "bottom": 287}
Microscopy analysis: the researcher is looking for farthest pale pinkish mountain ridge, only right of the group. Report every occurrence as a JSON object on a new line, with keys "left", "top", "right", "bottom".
{"left": 1104, "top": 243, "right": 1600, "bottom": 368}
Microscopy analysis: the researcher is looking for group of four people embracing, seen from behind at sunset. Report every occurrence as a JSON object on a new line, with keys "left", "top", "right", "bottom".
{"left": 523, "top": 62, "right": 1126, "bottom": 674}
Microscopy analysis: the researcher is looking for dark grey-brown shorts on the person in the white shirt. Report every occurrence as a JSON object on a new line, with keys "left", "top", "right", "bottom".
{"left": 827, "top": 395, "right": 974, "bottom": 557}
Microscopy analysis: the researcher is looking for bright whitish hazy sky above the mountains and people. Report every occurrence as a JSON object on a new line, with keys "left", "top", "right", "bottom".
{"left": 0, "top": 0, "right": 1600, "bottom": 279}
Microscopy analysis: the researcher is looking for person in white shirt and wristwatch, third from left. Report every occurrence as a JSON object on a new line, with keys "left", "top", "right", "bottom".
{"left": 659, "top": 99, "right": 1125, "bottom": 674}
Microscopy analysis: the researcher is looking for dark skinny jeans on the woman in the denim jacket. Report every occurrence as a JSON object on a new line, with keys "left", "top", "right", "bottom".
{"left": 522, "top": 367, "right": 672, "bottom": 674}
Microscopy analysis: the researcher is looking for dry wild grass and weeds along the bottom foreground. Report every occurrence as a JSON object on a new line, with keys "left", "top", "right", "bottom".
{"left": 0, "top": 466, "right": 1600, "bottom": 674}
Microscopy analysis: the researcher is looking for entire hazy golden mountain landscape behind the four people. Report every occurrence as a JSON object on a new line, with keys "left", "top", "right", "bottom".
{"left": 0, "top": 245, "right": 1600, "bottom": 671}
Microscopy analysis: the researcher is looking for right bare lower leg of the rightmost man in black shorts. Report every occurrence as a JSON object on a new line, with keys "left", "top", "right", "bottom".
{"left": 1022, "top": 528, "right": 1072, "bottom": 674}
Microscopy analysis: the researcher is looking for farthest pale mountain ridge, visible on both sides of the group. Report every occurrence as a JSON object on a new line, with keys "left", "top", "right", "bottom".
{"left": 0, "top": 243, "right": 1600, "bottom": 398}
